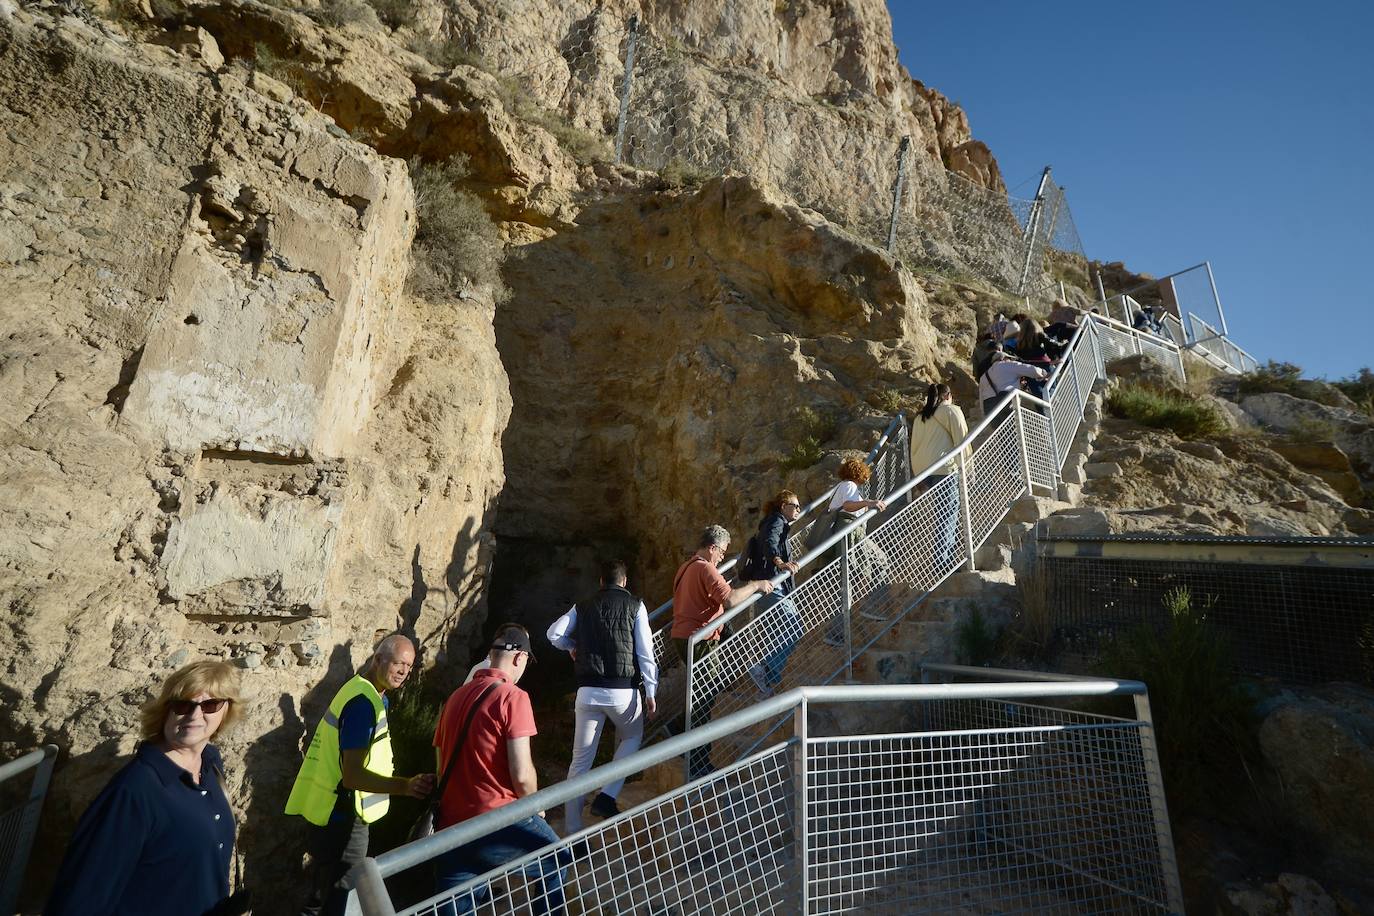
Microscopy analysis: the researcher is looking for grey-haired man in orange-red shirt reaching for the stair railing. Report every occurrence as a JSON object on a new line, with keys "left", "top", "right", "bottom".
{"left": 669, "top": 525, "right": 772, "bottom": 779}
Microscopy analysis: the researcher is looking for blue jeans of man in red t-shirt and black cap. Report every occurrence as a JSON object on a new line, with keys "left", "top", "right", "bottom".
{"left": 434, "top": 816, "right": 572, "bottom": 916}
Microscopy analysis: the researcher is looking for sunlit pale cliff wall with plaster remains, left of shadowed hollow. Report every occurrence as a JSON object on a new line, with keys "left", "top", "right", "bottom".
{"left": 0, "top": 10, "right": 510, "bottom": 895}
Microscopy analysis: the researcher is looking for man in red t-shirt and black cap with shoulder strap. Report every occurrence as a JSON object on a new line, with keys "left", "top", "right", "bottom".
{"left": 434, "top": 623, "right": 567, "bottom": 913}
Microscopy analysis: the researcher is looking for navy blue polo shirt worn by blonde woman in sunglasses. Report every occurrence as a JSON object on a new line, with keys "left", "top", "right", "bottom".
{"left": 43, "top": 744, "right": 234, "bottom": 916}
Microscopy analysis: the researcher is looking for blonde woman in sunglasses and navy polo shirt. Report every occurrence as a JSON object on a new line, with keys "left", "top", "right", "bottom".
{"left": 44, "top": 661, "right": 246, "bottom": 916}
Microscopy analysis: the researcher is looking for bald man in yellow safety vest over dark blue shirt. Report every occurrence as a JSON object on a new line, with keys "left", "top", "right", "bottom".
{"left": 278, "top": 633, "right": 434, "bottom": 916}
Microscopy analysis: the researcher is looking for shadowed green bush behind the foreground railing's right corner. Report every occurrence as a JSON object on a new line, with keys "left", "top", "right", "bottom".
{"left": 1101, "top": 588, "right": 1257, "bottom": 814}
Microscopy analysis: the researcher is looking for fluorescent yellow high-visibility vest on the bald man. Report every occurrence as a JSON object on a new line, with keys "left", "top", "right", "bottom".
{"left": 286, "top": 674, "right": 394, "bottom": 827}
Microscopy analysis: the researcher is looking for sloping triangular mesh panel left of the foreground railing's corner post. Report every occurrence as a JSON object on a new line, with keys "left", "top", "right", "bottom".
{"left": 401, "top": 743, "right": 798, "bottom": 916}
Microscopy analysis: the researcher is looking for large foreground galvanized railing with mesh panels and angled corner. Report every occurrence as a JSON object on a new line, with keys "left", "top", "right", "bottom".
{"left": 350, "top": 666, "right": 1183, "bottom": 916}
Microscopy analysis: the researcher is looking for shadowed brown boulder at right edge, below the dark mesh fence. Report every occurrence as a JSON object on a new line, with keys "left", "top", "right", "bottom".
{"left": 1260, "top": 684, "right": 1374, "bottom": 875}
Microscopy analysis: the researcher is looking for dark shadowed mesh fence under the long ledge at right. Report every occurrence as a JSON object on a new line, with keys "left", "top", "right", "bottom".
{"left": 1037, "top": 556, "right": 1374, "bottom": 685}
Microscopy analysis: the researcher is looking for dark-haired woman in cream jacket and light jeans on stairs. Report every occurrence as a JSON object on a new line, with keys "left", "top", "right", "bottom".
{"left": 911, "top": 383, "right": 970, "bottom": 574}
